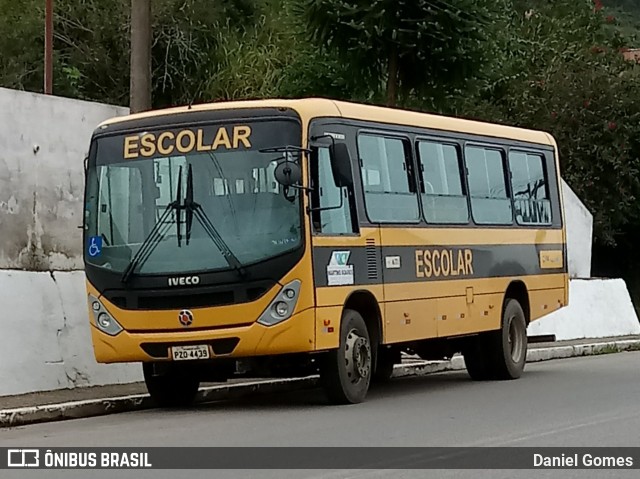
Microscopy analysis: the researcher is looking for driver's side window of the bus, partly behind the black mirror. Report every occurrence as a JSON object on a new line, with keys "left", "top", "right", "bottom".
{"left": 311, "top": 147, "right": 355, "bottom": 235}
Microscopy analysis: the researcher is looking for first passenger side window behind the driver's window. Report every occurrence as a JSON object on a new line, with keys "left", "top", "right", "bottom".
{"left": 358, "top": 135, "right": 420, "bottom": 223}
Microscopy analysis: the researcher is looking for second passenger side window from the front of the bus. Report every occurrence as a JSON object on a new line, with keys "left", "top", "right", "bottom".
{"left": 418, "top": 141, "right": 469, "bottom": 224}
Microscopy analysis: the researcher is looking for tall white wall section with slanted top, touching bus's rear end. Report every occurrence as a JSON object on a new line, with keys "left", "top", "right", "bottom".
{"left": 562, "top": 180, "right": 593, "bottom": 278}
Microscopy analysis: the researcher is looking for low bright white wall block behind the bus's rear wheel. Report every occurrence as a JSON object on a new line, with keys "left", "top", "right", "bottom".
{"left": 528, "top": 279, "right": 640, "bottom": 341}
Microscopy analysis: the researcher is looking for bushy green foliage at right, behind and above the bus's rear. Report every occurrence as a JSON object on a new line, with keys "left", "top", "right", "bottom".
{"left": 466, "top": 0, "right": 640, "bottom": 245}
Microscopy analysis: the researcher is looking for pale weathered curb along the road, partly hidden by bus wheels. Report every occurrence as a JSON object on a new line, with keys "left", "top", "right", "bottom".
{"left": 0, "top": 340, "right": 640, "bottom": 428}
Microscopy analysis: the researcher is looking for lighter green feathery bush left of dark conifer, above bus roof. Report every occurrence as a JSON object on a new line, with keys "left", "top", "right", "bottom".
{"left": 200, "top": 0, "right": 355, "bottom": 100}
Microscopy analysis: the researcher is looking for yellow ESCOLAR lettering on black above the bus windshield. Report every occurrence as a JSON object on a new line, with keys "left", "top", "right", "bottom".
{"left": 123, "top": 125, "right": 251, "bottom": 159}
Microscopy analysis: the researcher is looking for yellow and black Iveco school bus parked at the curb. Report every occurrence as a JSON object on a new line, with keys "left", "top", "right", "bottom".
{"left": 83, "top": 99, "right": 568, "bottom": 406}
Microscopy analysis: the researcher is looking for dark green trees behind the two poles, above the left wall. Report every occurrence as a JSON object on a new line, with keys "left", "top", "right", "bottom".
{"left": 0, "top": 0, "right": 259, "bottom": 107}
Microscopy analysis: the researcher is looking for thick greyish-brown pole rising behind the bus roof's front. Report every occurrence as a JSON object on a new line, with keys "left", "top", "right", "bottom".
{"left": 129, "top": 0, "right": 151, "bottom": 113}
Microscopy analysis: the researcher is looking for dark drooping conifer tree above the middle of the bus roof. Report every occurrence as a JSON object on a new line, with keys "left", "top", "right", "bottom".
{"left": 301, "top": 0, "right": 510, "bottom": 105}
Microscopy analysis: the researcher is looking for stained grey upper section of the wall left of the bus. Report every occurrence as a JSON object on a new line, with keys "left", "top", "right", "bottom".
{"left": 0, "top": 88, "right": 128, "bottom": 271}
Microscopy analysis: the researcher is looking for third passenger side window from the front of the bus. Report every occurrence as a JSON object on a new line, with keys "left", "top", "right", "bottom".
{"left": 465, "top": 146, "right": 513, "bottom": 225}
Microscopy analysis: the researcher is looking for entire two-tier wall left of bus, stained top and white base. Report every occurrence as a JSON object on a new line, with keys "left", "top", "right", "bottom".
{"left": 0, "top": 88, "right": 141, "bottom": 396}
